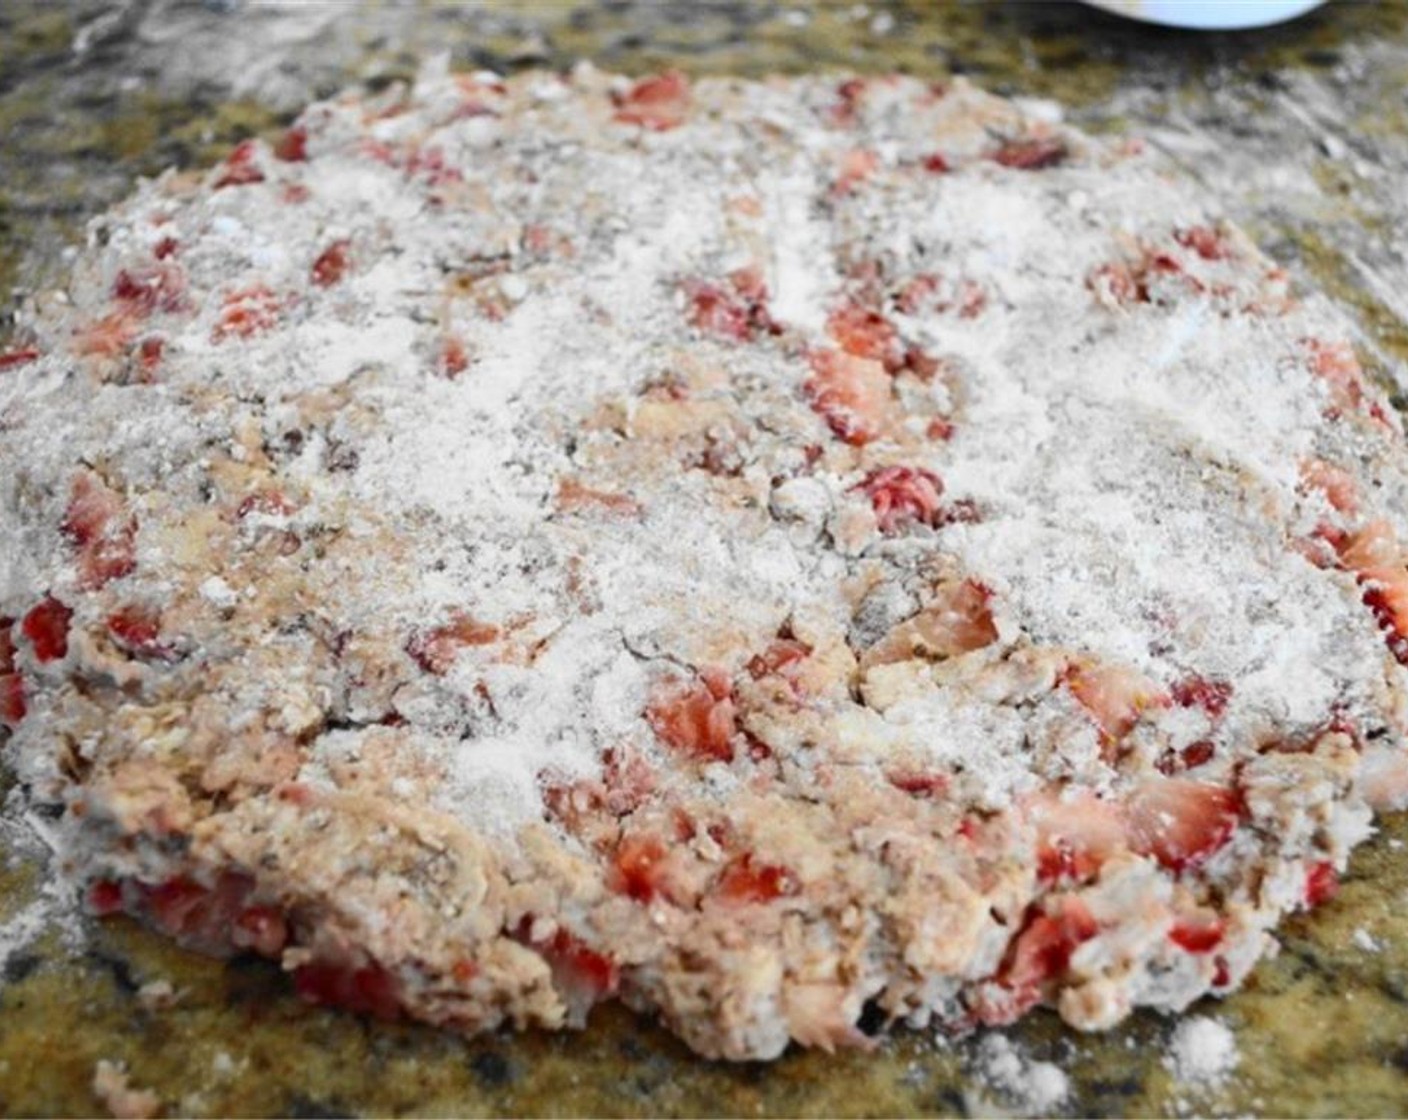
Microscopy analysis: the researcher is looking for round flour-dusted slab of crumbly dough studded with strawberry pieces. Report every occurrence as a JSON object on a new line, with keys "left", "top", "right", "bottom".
{"left": 0, "top": 68, "right": 1408, "bottom": 1058}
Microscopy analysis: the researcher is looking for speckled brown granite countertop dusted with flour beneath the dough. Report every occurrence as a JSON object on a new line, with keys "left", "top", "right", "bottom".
{"left": 0, "top": 0, "right": 1408, "bottom": 1116}
